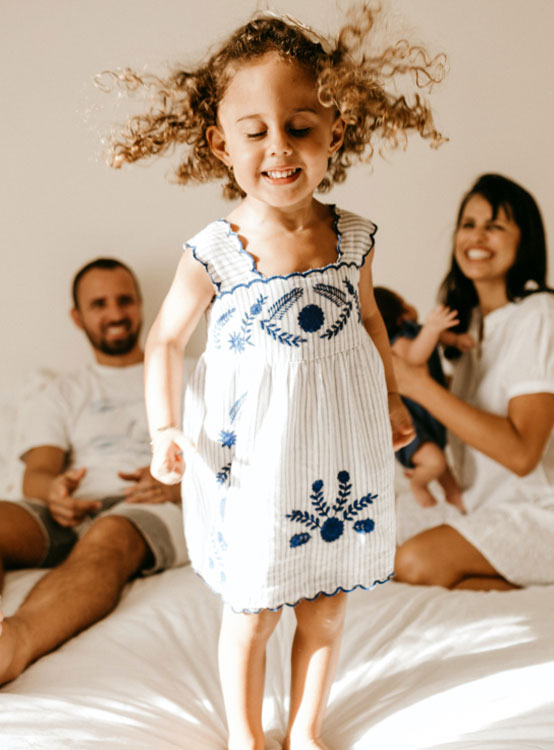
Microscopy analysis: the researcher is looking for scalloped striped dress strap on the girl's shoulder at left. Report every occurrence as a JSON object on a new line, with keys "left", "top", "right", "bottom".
{"left": 184, "top": 219, "right": 253, "bottom": 292}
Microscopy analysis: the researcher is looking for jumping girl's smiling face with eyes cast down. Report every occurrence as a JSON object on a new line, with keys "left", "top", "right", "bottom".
{"left": 207, "top": 53, "right": 345, "bottom": 210}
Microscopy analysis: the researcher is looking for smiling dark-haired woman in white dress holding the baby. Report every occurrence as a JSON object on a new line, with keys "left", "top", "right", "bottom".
{"left": 395, "top": 175, "right": 554, "bottom": 589}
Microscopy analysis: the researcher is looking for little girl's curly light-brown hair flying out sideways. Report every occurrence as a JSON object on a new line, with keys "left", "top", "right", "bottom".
{"left": 97, "top": 4, "right": 446, "bottom": 198}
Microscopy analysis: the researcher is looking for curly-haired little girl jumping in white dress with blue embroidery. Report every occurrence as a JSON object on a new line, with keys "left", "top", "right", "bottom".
{"left": 104, "top": 8, "right": 442, "bottom": 750}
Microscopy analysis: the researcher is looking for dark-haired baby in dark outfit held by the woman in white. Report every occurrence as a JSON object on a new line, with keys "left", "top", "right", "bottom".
{"left": 375, "top": 287, "right": 475, "bottom": 512}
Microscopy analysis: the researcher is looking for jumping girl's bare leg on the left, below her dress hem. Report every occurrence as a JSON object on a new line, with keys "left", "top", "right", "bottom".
{"left": 219, "top": 607, "right": 281, "bottom": 750}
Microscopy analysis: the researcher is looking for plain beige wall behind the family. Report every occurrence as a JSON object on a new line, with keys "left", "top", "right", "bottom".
{"left": 0, "top": 0, "right": 554, "bottom": 390}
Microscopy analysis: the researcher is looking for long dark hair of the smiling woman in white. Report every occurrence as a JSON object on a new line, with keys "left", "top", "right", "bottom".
{"left": 439, "top": 174, "right": 554, "bottom": 359}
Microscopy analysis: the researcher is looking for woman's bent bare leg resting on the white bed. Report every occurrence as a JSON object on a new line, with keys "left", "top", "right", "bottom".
{"left": 394, "top": 525, "right": 504, "bottom": 589}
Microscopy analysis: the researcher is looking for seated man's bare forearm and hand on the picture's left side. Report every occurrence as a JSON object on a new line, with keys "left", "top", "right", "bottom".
{"left": 23, "top": 445, "right": 101, "bottom": 526}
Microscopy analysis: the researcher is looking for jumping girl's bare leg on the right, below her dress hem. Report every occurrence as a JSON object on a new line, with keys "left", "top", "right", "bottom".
{"left": 283, "top": 593, "right": 346, "bottom": 750}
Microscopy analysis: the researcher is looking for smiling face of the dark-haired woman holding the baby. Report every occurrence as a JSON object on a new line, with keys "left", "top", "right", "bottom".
{"left": 454, "top": 195, "right": 521, "bottom": 282}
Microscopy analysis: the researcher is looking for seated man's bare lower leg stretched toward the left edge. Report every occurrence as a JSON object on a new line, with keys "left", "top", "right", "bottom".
{"left": 0, "top": 516, "right": 149, "bottom": 684}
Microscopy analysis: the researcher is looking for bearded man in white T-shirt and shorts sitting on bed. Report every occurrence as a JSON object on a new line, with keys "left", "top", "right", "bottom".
{"left": 0, "top": 259, "right": 186, "bottom": 683}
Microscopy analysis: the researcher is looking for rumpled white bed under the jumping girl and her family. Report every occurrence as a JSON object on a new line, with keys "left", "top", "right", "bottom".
{"left": 0, "top": 384, "right": 554, "bottom": 750}
